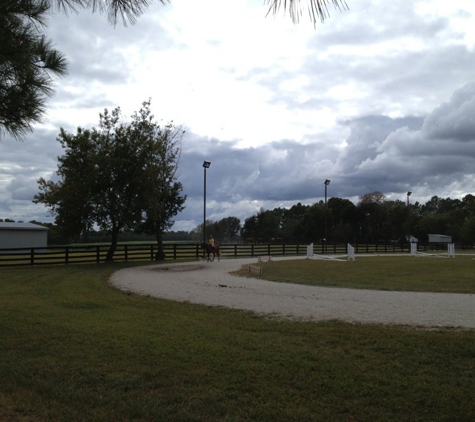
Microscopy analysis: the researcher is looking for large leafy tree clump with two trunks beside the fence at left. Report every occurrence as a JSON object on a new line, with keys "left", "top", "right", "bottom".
{"left": 34, "top": 101, "right": 186, "bottom": 261}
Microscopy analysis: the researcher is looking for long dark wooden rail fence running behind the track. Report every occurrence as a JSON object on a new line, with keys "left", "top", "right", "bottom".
{"left": 0, "top": 243, "right": 468, "bottom": 266}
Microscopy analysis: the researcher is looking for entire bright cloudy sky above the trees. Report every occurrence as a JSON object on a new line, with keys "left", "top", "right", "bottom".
{"left": 0, "top": 0, "right": 475, "bottom": 230}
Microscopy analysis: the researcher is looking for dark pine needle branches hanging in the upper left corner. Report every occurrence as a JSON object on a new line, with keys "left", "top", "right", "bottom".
{"left": 0, "top": 0, "right": 67, "bottom": 139}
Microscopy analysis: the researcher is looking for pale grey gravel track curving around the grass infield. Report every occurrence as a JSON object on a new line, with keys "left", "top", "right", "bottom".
{"left": 110, "top": 257, "right": 475, "bottom": 328}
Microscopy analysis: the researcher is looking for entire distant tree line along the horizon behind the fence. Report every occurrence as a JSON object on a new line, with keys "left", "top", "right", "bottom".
{"left": 0, "top": 192, "right": 475, "bottom": 245}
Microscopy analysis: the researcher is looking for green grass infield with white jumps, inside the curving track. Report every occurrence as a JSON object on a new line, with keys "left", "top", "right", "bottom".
{"left": 238, "top": 255, "right": 475, "bottom": 293}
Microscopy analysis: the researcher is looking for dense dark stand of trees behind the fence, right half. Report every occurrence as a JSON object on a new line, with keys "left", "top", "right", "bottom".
{"left": 241, "top": 191, "right": 475, "bottom": 244}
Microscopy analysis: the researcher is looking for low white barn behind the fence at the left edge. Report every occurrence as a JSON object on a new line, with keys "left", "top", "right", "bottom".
{"left": 0, "top": 222, "right": 48, "bottom": 249}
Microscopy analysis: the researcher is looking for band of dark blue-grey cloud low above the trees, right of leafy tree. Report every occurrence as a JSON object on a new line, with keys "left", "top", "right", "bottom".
{"left": 175, "top": 83, "right": 475, "bottom": 224}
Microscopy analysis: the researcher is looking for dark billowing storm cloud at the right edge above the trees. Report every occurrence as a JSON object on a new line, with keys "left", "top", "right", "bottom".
{"left": 348, "top": 83, "right": 475, "bottom": 195}
